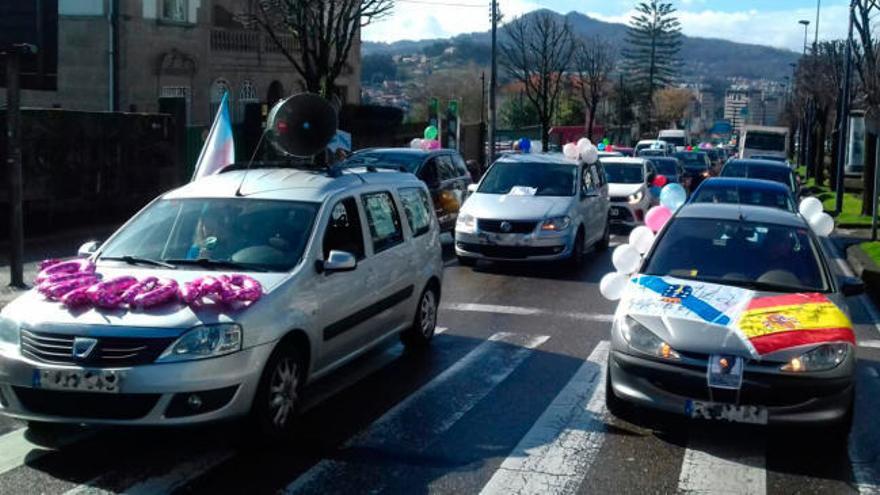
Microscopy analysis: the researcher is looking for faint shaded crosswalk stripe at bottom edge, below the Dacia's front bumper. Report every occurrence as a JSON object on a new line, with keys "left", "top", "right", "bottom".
{"left": 64, "top": 449, "right": 235, "bottom": 495}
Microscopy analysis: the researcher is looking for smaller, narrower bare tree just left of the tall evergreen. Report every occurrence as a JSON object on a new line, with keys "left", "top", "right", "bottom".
{"left": 574, "top": 36, "right": 614, "bottom": 139}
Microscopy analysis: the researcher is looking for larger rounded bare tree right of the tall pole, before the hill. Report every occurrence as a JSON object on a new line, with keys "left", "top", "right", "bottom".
{"left": 499, "top": 12, "right": 574, "bottom": 149}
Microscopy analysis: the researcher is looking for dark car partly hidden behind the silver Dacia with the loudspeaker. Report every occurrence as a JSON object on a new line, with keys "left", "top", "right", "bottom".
{"left": 342, "top": 148, "right": 473, "bottom": 232}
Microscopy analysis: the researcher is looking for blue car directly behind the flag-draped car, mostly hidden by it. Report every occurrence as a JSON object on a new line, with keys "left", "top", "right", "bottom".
{"left": 688, "top": 177, "right": 797, "bottom": 212}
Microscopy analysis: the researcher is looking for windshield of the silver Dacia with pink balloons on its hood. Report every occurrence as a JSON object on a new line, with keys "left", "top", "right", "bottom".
{"left": 101, "top": 198, "right": 319, "bottom": 271}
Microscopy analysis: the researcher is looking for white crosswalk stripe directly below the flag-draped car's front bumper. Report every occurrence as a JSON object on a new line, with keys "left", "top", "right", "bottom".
{"left": 678, "top": 431, "right": 767, "bottom": 495}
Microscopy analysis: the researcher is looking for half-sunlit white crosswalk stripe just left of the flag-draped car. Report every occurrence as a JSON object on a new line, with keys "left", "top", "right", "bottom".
{"left": 480, "top": 340, "right": 608, "bottom": 495}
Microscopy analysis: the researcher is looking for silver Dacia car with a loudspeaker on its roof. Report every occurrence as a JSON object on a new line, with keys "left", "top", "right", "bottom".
{"left": 0, "top": 169, "right": 443, "bottom": 438}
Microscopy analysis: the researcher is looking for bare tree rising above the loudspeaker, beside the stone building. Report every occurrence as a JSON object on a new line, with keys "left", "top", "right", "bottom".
{"left": 237, "top": 0, "right": 394, "bottom": 97}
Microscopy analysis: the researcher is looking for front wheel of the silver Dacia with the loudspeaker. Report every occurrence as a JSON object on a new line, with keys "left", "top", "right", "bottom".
{"left": 250, "top": 342, "right": 306, "bottom": 443}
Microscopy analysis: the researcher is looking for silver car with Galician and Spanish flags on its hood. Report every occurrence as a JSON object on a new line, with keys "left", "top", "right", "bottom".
{"left": 606, "top": 203, "right": 864, "bottom": 441}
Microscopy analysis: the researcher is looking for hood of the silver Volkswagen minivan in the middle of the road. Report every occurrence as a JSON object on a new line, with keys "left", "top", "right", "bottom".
{"left": 461, "top": 193, "right": 573, "bottom": 220}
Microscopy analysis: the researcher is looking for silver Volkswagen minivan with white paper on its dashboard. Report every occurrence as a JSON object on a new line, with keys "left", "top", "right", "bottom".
{"left": 455, "top": 153, "right": 611, "bottom": 267}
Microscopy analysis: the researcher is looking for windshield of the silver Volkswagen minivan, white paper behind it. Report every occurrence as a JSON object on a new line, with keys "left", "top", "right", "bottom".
{"left": 478, "top": 163, "right": 578, "bottom": 196}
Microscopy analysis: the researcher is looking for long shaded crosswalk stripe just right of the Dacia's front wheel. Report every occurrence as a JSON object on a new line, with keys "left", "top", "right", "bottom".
{"left": 284, "top": 333, "right": 550, "bottom": 493}
